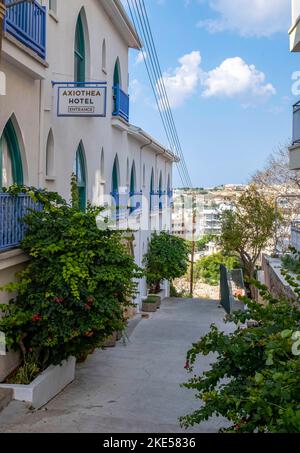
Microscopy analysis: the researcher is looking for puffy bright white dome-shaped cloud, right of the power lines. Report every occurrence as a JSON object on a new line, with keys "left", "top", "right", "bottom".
{"left": 202, "top": 57, "right": 276, "bottom": 99}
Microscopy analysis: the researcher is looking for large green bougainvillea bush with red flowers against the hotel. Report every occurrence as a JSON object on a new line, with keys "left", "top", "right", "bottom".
{"left": 0, "top": 187, "right": 141, "bottom": 370}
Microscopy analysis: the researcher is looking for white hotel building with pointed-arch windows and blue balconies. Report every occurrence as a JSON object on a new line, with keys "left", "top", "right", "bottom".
{"left": 0, "top": 0, "right": 176, "bottom": 380}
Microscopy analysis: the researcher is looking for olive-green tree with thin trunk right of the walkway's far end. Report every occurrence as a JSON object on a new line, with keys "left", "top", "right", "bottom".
{"left": 221, "top": 185, "right": 276, "bottom": 279}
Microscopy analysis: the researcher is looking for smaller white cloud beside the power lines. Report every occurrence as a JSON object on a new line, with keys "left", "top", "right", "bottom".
{"left": 157, "top": 51, "right": 201, "bottom": 107}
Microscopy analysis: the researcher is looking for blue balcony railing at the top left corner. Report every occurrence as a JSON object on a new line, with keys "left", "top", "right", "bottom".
{"left": 4, "top": 0, "right": 46, "bottom": 60}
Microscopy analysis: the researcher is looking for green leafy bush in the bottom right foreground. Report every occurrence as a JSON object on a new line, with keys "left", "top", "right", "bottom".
{"left": 181, "top": 278, "right": 300, "bottom": 433}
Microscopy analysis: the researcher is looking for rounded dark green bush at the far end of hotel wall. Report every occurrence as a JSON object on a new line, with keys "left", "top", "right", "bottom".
{"left": 144, "top": 232, "right": 189, "bottom": 292}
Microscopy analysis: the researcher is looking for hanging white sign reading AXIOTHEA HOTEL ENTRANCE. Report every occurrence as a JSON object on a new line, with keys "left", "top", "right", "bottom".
{"left": 57, "top": 83, "right": 107, "bottom": 117}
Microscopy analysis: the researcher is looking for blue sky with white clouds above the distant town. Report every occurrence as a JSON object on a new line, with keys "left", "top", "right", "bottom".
{"left": 125, "top": 0, "right": 300, "bottom": 187}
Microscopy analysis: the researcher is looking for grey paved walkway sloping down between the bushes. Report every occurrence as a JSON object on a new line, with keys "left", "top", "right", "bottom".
{"left": 0, "top": 299, "right": 232, "bottom": 433}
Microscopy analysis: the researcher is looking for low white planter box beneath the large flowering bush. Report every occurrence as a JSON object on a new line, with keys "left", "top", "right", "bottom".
{"left": 0, "top": 357, "right": 76, "bottom": 409}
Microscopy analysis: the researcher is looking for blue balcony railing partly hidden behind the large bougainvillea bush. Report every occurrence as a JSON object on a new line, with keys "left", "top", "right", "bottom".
{"left": 0, "top": 193, "right": 41, "bottom": 252}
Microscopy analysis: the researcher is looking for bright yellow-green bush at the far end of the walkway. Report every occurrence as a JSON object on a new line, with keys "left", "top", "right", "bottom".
{"left": 195, "top": 253, "right": 241, "bottom": 286}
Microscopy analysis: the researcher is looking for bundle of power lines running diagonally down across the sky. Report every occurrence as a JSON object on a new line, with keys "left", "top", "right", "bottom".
{"left": 127, "top": 0, "right": 192, "bottom": 187}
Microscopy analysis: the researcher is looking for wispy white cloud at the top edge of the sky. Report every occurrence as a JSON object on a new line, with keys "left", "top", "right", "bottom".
{"left": 198, "top": 0, "right": 291, "bottom": 36}
